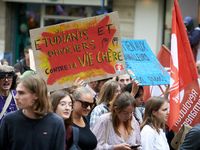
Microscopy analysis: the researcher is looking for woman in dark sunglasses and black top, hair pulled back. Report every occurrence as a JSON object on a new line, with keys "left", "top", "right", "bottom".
{"left": 72, "top": 87, "right": 97, "bottom": 150}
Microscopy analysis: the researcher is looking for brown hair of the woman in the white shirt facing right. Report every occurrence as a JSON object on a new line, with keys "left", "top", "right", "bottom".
{"left": 140, "top": 96, "right": 168, "bottom": 133}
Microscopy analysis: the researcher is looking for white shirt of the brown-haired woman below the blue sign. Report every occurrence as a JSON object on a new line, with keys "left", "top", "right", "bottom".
{"left": 141, "top": 125, "right": 169, "bottom": 150}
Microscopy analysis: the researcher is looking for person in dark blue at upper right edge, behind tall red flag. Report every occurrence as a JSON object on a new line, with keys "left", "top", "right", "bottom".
{"left": 183, "top": 16, "right": 200, "bottom": 62}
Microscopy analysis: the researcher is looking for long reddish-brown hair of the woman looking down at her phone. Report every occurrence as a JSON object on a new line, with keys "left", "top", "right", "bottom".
{"left": 111, "top": 92, "right": 136, "bottom": 136}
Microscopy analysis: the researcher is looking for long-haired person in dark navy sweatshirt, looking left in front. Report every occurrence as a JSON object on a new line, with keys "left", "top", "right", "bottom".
{"left": 0, "top": 75, "right": 65, "bottom": 150}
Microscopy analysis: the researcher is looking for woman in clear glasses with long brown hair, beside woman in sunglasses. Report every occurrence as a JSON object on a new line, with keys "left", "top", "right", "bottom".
{"left": 50, "top": 90, "right": 73, "bottom": 150}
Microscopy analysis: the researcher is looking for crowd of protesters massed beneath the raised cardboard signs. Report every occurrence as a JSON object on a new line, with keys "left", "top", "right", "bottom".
{"left": 0, "top": 43, "right": 198, "bottom": 150}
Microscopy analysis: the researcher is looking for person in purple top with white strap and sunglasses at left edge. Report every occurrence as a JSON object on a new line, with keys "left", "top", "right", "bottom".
{"left": 0, "top": 65, "right": 17, "bottom": 125}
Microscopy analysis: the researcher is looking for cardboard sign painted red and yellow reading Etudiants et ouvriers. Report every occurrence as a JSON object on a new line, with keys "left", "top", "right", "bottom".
{"left": 30, "top": 12, "right": 126, "bottom": 91}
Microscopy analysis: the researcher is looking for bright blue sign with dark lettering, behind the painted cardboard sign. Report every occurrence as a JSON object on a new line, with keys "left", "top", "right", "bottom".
{"left": 122, "top": 39, "right": 170, "bottom": 85}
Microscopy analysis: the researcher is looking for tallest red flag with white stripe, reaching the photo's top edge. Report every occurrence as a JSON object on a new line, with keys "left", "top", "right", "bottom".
{"left": 169, "top": 0, "right": 198, "bottom": 129}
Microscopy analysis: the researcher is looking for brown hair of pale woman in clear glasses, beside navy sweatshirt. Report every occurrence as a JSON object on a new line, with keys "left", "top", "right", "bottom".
{"left": 50, "top": 90, "right": 74, "bottom": 126}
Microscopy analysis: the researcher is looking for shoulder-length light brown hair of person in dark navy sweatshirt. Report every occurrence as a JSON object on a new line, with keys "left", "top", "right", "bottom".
{"left": 17, "top": 75, "right": 53, "bottom": 117}
